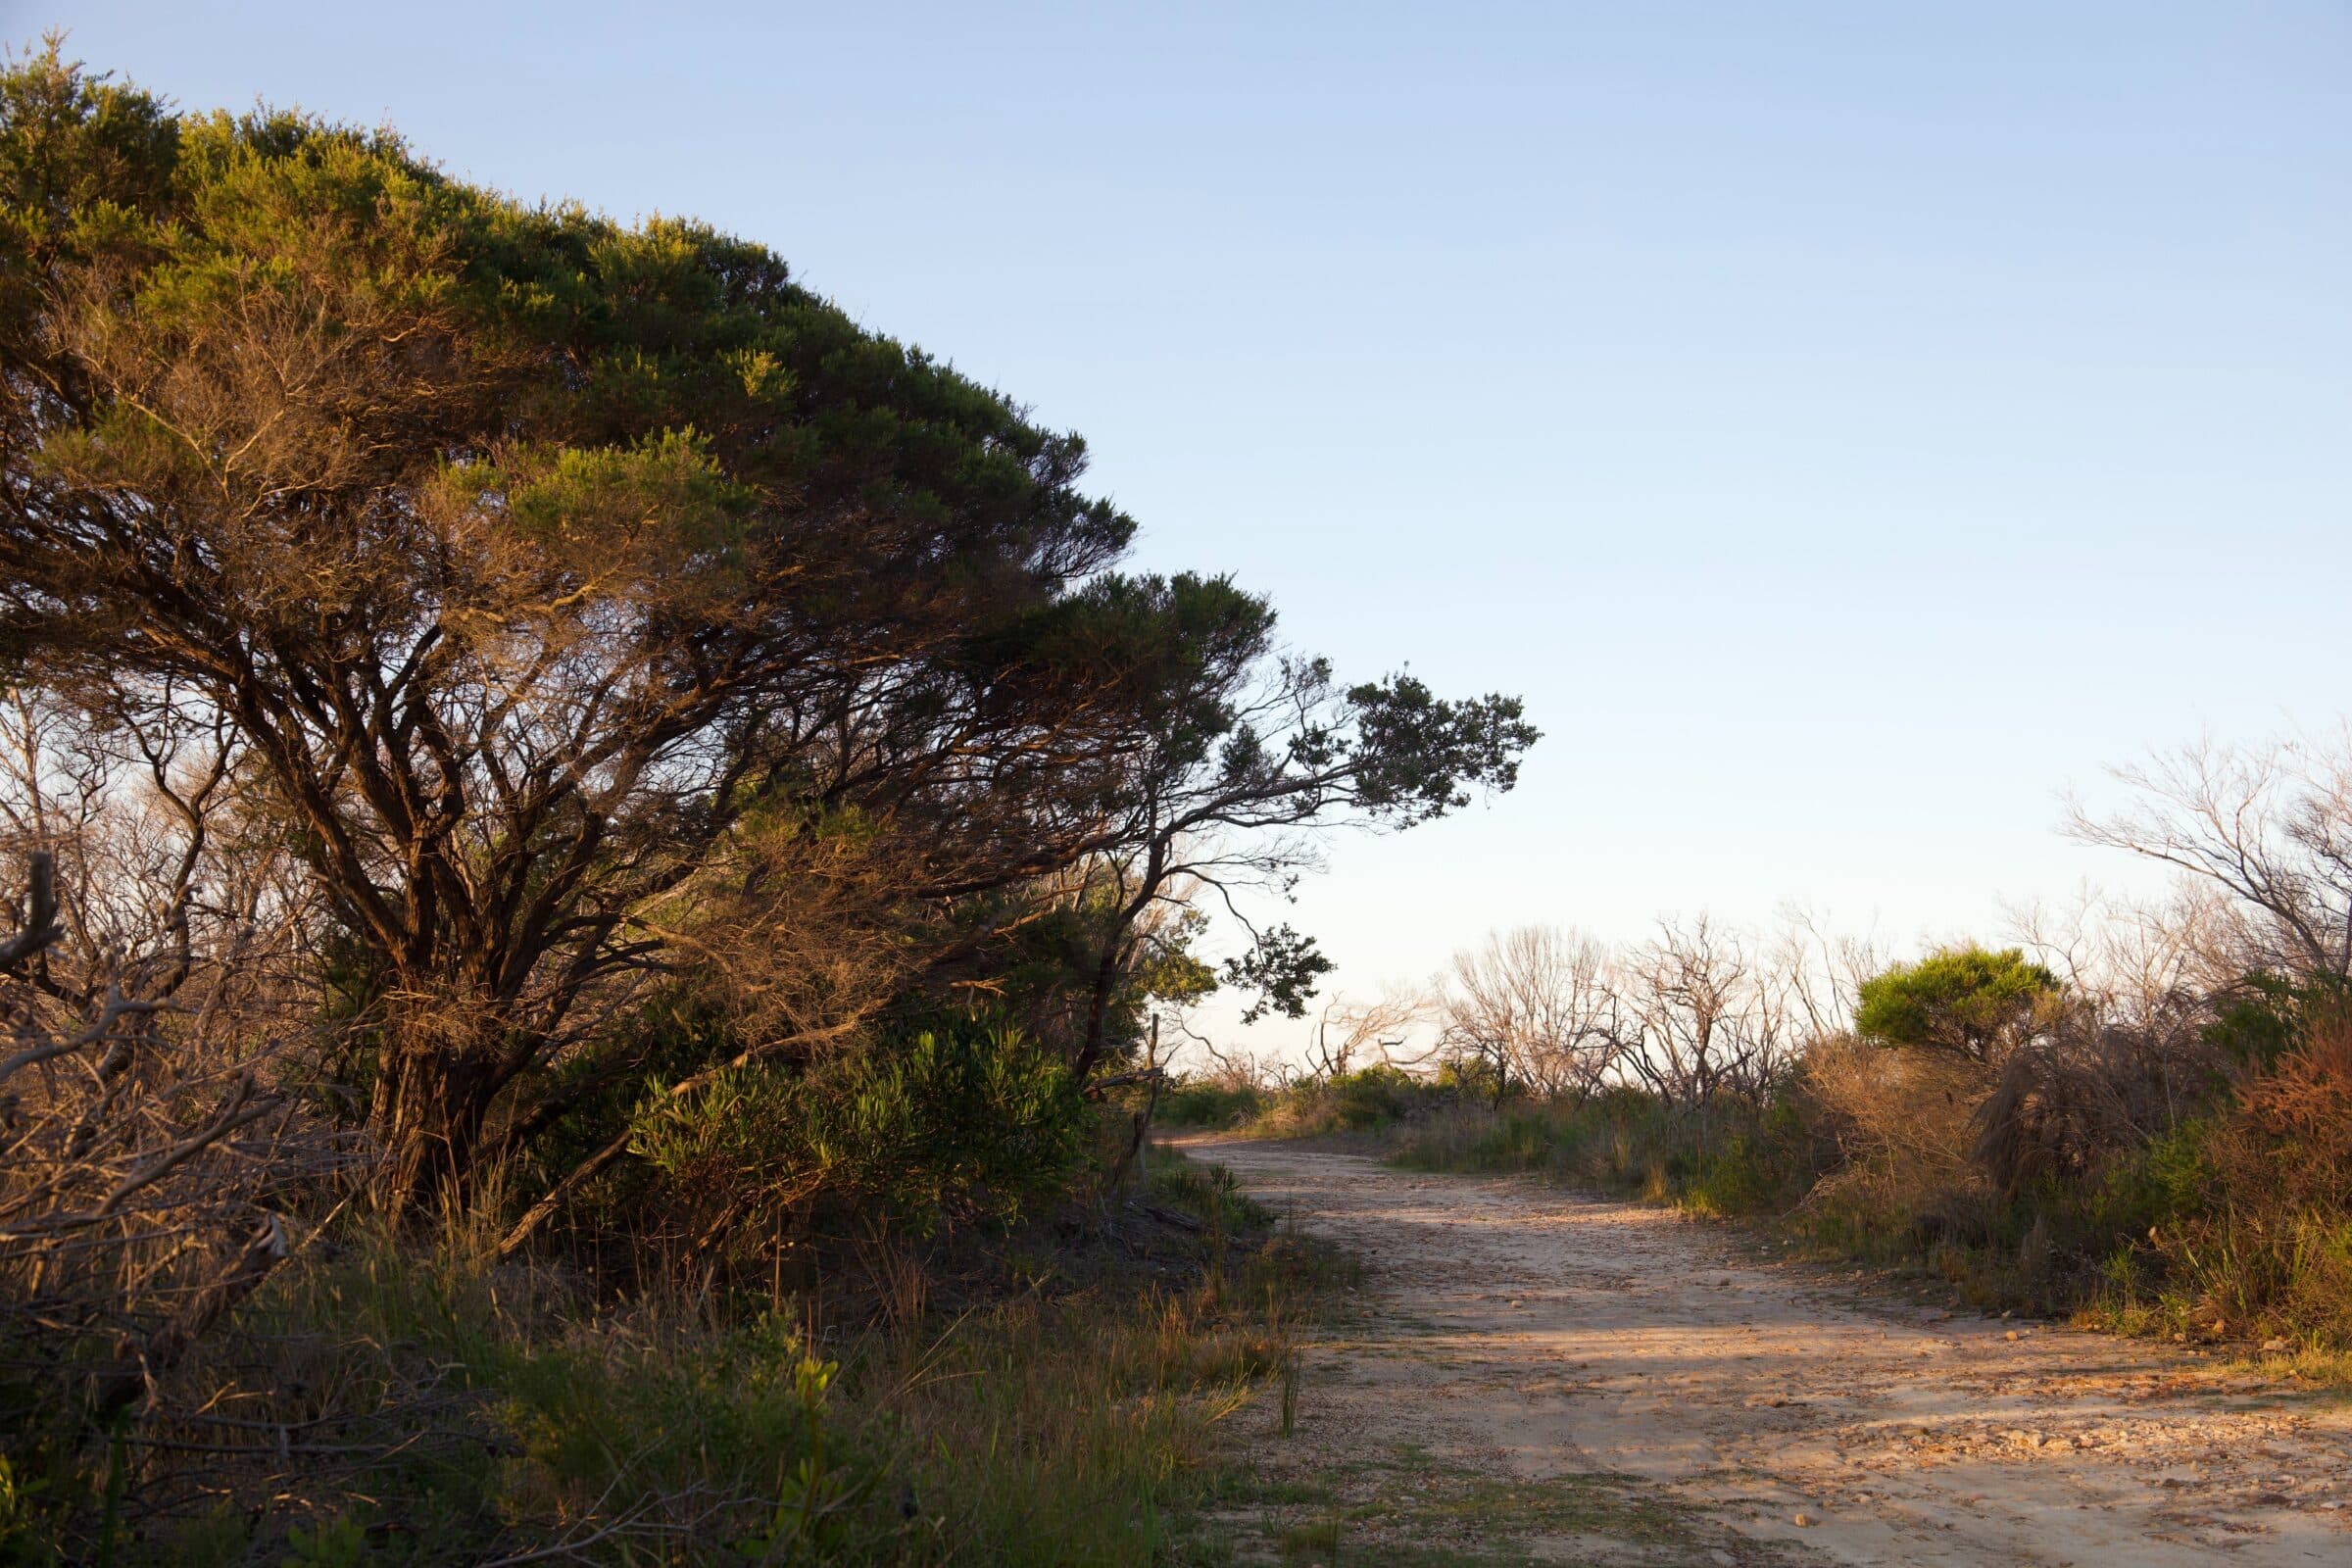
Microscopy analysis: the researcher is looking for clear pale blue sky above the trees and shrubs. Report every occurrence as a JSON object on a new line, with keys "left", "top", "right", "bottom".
{"left": 23, "top": 0, "right": 2352, "bottom": 1049}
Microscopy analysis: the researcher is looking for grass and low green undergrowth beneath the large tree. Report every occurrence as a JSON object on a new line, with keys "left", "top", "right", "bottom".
{"left": 0, "top": 1152, "right": 1350, "bottom": 1568}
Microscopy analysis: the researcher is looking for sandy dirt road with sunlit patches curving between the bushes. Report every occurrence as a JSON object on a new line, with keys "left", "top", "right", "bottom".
{"left": 1186, "top": 1140, "right": 2352, "bottom": 1568}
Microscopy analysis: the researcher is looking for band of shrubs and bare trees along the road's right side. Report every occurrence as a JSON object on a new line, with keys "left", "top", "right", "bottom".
{"left": 1164, "top": 738, "right": 2352, "bottom": 1375}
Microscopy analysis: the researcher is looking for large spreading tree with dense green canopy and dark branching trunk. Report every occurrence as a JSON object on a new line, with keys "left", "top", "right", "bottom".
{"left": 0, "top": 47, "right": 1534, "bottom": 1199}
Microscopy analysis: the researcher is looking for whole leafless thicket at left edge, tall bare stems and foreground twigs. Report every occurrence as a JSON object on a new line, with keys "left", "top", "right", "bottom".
{"left": 0, "top": 691, "right": 348, "bottom": 1533}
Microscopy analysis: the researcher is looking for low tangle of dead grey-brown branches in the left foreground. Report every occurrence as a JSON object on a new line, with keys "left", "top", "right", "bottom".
{"left": 0, "top": 854, "right": 327, "bottom": 1434}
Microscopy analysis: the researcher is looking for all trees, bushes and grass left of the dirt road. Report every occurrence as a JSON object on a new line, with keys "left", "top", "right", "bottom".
{"left": 0, "top": 40, "right": 1486, "bottom": 1566}
